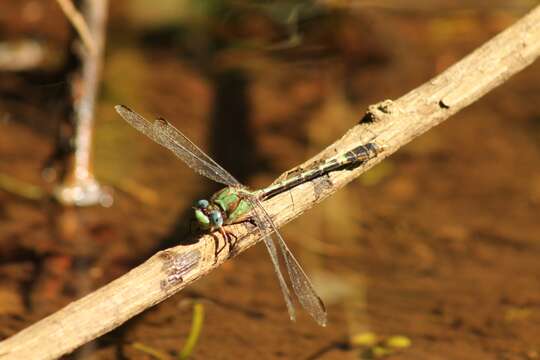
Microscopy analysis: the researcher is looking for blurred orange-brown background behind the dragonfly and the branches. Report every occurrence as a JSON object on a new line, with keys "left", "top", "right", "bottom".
{"left": 0, "top": 0, "right": 540, "bottom": 359}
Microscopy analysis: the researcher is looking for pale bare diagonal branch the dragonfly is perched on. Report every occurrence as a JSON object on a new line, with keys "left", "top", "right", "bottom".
{"left": 0, "top": 6, "right": 540, "bottom": 359}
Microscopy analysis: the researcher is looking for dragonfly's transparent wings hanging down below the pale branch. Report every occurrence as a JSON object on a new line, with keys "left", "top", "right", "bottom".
{"left": 251, "top": 199, "right": 327, "bottom": 326}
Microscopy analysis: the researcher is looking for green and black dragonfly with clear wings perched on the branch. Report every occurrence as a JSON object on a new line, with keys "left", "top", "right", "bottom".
{"left": 115, "top": 105, "right": 381, "bottom": 326}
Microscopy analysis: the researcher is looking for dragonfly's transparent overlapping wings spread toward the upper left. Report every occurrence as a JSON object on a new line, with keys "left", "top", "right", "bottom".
{"left": 114, "top": 105, "right": 240, "bottom": 186}
